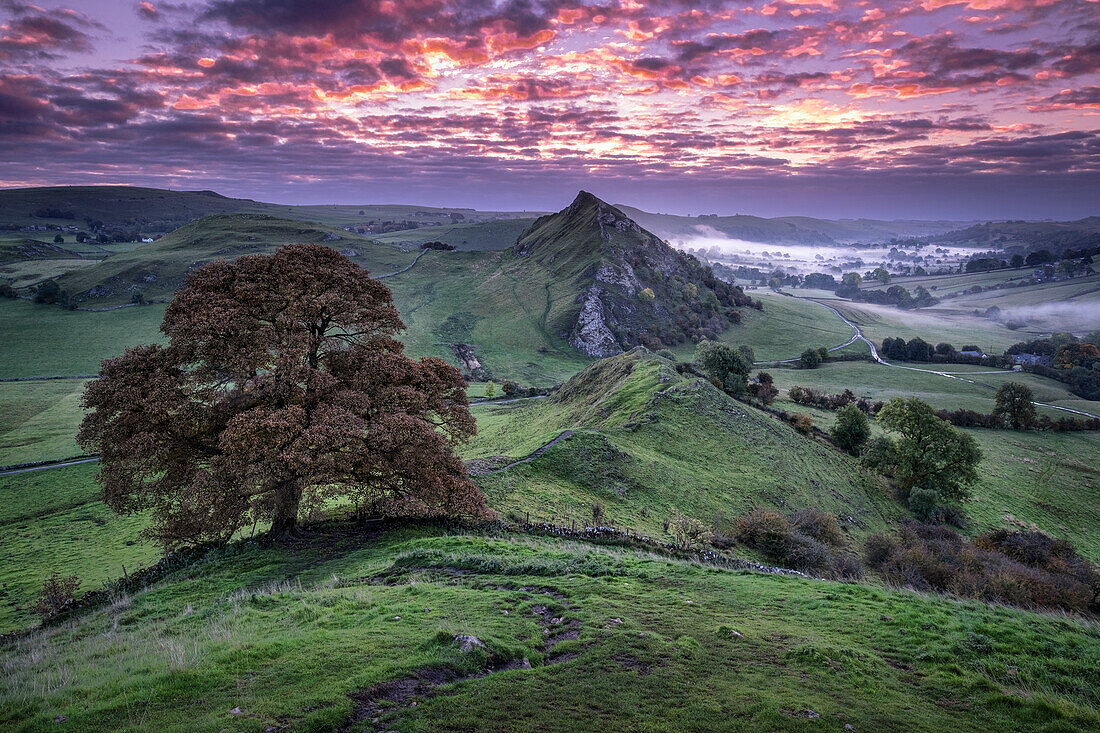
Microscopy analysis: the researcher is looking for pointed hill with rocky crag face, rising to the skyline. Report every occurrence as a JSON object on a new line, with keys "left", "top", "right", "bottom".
{"left": 514, "top": 190, "right": 752, "bottom": 358}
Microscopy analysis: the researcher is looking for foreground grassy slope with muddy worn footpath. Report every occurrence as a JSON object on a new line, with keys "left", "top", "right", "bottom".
{"left": 0, "top": 529, "right": 1100, "bottom": 732}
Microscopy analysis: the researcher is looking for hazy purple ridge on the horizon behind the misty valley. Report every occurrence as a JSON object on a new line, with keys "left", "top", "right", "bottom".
{"left": 619, "top": 206, "right": 972, "bottom": 244}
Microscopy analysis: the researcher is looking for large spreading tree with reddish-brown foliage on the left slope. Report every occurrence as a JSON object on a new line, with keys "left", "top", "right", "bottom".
{"left": 78, "top": 244, "right": 486, "bottom": 546}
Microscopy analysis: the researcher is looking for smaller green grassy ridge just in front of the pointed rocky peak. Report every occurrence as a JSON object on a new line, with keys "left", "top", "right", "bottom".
{"left": 464, "top": 350, "right": 903, "bottom": 536}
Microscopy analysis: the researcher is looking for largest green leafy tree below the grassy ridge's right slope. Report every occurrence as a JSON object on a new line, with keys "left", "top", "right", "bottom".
{"left": 877, "top": 397, "right": 981, "bottom": 502}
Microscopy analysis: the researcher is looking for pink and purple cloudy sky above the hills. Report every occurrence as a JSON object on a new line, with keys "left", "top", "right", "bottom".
{"left": 0, "top": 0, "right": 1100, "bottom": 220}
